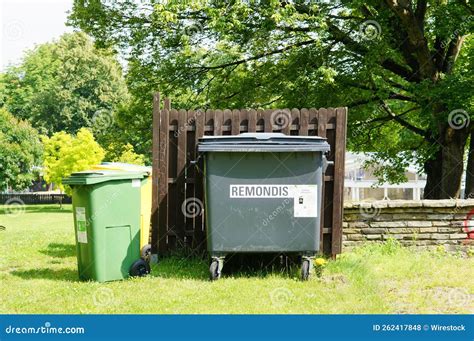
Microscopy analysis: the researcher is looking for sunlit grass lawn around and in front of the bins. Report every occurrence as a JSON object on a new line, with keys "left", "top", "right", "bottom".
{"left": 0, "top": 205, "right": 474, "bottom": 314}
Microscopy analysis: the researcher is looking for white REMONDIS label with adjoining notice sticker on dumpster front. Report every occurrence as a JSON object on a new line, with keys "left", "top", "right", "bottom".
{"left": 229, "top": 185, "right": 318, "bottom": 218}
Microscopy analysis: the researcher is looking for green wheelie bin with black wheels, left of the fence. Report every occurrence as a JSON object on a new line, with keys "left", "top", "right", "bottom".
{"left": 63, "top": 170, "right": 150, "bottom": 282}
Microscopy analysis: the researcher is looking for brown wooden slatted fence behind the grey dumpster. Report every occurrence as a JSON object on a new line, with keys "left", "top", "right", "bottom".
{"left": 151, "top": 93, "right": 347, "bottom": 256}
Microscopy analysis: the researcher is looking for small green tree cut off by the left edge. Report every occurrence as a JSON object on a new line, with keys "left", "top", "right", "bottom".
{"left": 0, "top": 108, "right": 42, "bottom": 190}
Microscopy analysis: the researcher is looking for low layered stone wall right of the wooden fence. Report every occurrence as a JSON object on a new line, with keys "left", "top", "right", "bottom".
{"left": 342, "top": 199, "right": 474, "bottom": 250}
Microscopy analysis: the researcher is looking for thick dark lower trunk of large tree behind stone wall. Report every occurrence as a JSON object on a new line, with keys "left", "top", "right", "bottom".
{"left": 423, "top": 124, "right": 468, "bottom": 199}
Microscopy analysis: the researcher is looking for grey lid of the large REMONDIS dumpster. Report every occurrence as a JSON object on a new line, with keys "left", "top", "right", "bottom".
{"left": 198, "top": 133, "right": 330, "bottom": 152}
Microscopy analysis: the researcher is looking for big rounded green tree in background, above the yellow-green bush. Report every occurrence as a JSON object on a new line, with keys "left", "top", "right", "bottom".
{"left": 0, "top": 32, "right": 128, "bottom": 137}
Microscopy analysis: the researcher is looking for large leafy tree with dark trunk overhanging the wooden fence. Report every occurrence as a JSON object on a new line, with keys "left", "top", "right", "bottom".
{"left": 70, "top": 0, "right": 474, "bottom": 198}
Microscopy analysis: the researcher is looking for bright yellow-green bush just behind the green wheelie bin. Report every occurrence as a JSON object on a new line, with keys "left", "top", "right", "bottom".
{"left": 43, "top": 128, "right": 105, "bottom": 193}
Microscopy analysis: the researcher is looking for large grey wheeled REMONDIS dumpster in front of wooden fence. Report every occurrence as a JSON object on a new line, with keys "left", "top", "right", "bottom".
{"left": 198, "top": 133, "right": 329, "bottom": 280}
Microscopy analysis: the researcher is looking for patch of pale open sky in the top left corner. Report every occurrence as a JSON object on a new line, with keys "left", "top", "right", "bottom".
{"left": 0, "top": 0, "right": 73, "bottom": 70}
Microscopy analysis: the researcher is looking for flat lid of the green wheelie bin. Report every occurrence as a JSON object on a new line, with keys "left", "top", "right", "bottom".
{"left": 63, "top": 170, "right": 148, "bottom": 185}
